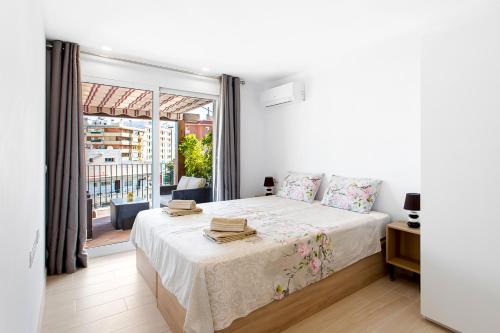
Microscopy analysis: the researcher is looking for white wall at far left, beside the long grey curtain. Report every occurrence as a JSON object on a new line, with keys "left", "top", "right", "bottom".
{"left": 0, "top": 0, "right": 45, "bottom": 333}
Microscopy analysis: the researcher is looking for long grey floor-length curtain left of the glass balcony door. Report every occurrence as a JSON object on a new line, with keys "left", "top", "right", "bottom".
{"left": 46, "top": 41, "right": 87, "bottom": 274}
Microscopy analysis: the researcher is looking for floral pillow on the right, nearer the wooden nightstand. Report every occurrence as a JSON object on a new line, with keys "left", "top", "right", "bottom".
{"left": 321, "top": 175, "right": 381, "bottom": 213}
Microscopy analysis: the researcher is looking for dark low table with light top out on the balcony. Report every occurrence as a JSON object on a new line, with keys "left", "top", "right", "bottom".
{"left": 110, "top": 198, "right": 149, "bottom": 230}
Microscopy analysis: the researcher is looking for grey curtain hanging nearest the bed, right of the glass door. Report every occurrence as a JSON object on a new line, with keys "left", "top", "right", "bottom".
{"left": 214, "top": 74, "right": 240, "bottom": 201}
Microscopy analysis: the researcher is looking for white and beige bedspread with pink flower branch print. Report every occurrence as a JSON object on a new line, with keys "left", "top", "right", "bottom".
{"left": 131, "top": 196, "right": 389, "bottom": 333}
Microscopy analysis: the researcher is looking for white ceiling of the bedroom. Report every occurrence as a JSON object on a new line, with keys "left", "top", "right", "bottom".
{"left": 43, "top": 0, "right": 487, "bottom": 80}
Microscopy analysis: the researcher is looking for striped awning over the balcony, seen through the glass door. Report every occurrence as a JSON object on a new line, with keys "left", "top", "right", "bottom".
{"left": 82, "top": 82, "right": 212, "bottom": 120}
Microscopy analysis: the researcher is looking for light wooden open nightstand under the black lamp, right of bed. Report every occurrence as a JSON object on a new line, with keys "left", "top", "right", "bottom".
{"left": 386, "top": 221, "right": 420, "bottom": 280}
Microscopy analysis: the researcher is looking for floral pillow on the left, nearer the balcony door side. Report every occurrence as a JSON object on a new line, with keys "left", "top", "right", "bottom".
{"left": 276, "top": 172, "right": 323, "bottom": 203}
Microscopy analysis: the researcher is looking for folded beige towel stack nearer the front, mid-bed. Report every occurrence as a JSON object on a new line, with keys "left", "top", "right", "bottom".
{"left": 203, "top": 217, "right": 256, "bottom": 243}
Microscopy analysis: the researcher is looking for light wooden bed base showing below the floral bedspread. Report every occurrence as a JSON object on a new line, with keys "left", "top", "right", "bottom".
{"left": 136, "top": 240, "right": 387, "bottom": 333}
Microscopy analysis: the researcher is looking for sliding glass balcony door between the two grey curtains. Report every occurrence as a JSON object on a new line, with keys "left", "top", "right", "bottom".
{"left": 82, "top": 82, "right": 215, "bottom": 247}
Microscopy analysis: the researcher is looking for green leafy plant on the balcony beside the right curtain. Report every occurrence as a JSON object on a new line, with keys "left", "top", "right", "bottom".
{"left": 179, "top": 133, "right": 213, "bottom": 183}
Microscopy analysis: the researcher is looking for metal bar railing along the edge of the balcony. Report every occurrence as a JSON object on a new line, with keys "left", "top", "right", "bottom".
{"left": 87, "top": 162, "right": 174, "bottom": 208}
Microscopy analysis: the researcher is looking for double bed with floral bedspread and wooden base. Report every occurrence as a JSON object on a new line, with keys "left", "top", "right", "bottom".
{"left": 131, "top": 196, "right": 390, "bottom": 333}
